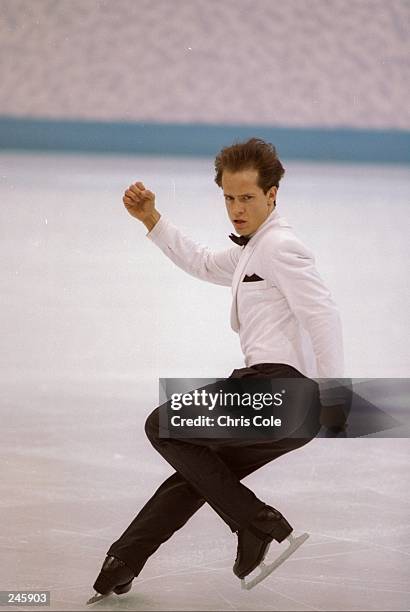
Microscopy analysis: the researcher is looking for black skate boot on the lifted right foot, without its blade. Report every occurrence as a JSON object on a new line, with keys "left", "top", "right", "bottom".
{"left": 233, "top": 506, "right": 293, "bottom": 579}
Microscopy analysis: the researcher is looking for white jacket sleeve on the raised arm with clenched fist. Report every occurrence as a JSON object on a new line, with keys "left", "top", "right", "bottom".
{"left": 147, "top": 215, "right": 242, "bottom": 286}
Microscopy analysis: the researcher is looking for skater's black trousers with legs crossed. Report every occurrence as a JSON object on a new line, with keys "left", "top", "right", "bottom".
{"left": 107, "top": 363, "right": 320, "bottom": 575}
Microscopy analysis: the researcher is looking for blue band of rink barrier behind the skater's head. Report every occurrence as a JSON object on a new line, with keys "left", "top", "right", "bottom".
{"left": 0, "top": 116, "right": 410, "bottom": 164}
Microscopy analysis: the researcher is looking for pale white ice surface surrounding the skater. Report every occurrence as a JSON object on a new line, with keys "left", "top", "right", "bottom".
{"left": 0, "top": 153, "right": 410, "bottom": 611}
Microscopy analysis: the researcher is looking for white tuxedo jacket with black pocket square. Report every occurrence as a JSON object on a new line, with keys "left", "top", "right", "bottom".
{"left": 147, "top": 210, "right": 343, "bottom": 378}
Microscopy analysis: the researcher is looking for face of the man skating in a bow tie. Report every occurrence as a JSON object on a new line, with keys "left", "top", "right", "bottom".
{"left": 222, "top": 169, "right": 277, "bottom": 236}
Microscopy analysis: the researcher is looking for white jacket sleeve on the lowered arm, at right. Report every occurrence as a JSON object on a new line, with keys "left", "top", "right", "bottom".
{"left": 264, "top": 235, "right": 344, "bottom": 378}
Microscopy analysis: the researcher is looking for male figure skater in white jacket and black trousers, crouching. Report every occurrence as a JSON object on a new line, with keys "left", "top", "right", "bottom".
{"left": 89, "top": 138, "right": 344, "bottom": 594}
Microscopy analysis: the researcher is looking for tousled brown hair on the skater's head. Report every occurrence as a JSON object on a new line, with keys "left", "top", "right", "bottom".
{"left": 215, "top": 138, "right": 285, "bottom": 194}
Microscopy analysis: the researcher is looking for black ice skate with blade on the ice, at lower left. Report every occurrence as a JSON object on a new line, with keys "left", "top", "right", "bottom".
{"left": 87, "top": 555, "right": 135, "bottom": 605}
